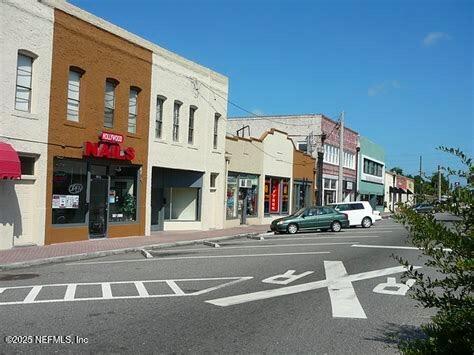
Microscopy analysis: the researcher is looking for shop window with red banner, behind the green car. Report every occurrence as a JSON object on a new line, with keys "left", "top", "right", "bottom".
{"left": 264, "top": 177, "right": 290, "bottom": 214}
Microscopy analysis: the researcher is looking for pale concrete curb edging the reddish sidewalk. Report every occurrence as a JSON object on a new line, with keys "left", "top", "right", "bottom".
{"left": 0, "top": 232, "right": 259, "bottom": 271}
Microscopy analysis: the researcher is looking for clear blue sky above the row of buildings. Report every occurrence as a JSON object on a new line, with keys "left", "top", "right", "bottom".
{"left": 69, "top": 0, "right": 474, "bottom": 175}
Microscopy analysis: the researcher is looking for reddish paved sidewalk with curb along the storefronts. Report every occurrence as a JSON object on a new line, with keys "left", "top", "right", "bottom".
{"left": 0, "top": 225, "right": 269, "bottom": 271}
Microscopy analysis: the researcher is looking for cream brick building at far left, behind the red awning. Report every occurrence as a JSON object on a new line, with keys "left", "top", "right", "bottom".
{"left": 0, "top": 0, "right": 54, "bottom": 249}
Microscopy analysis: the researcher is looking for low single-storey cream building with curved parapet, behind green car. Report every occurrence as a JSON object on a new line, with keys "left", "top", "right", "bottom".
{"left": 225, "top": 129, "right": 295, "bottom": 227}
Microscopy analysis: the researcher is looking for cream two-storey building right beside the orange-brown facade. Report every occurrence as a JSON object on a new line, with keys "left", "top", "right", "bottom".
{"left": 146, "top": 46, "right": 228, "bottom": 234}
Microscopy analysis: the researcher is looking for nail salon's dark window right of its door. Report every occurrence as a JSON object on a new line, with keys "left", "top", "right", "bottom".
{"left": 108, "top": 165, "right": 138, "bottom": 222}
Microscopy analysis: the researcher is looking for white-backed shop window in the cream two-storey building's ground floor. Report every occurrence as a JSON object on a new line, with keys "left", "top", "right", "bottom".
{"left": 164, "top": 187, "right": 200, "bottom": 221}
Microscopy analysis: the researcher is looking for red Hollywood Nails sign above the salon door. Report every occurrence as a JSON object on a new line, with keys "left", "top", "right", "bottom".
{"left": 83, "top": 132, "right": 135, "bottom": 160}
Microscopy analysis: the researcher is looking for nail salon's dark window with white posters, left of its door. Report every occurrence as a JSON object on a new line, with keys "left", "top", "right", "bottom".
{"left": 52, "top": 158, "right": 87, "bottom": 224}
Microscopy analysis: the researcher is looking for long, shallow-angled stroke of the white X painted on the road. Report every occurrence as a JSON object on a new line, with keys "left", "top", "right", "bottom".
{"left": 205, "top": 266, "right": 421, "bottom": 307}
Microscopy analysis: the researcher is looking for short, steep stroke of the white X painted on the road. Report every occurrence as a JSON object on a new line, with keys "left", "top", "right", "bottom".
{"left": 324, "top": 261, "right": 367, "bottom": 319}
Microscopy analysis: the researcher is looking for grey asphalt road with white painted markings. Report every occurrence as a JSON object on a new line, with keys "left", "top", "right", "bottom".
{"left": 0, "top": 220, "right": 430, "bottom": 354}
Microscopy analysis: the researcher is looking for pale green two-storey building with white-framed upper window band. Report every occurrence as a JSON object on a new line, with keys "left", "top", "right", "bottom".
{"left": 357, "top": 137, "right": 385, "bottom": 212}
